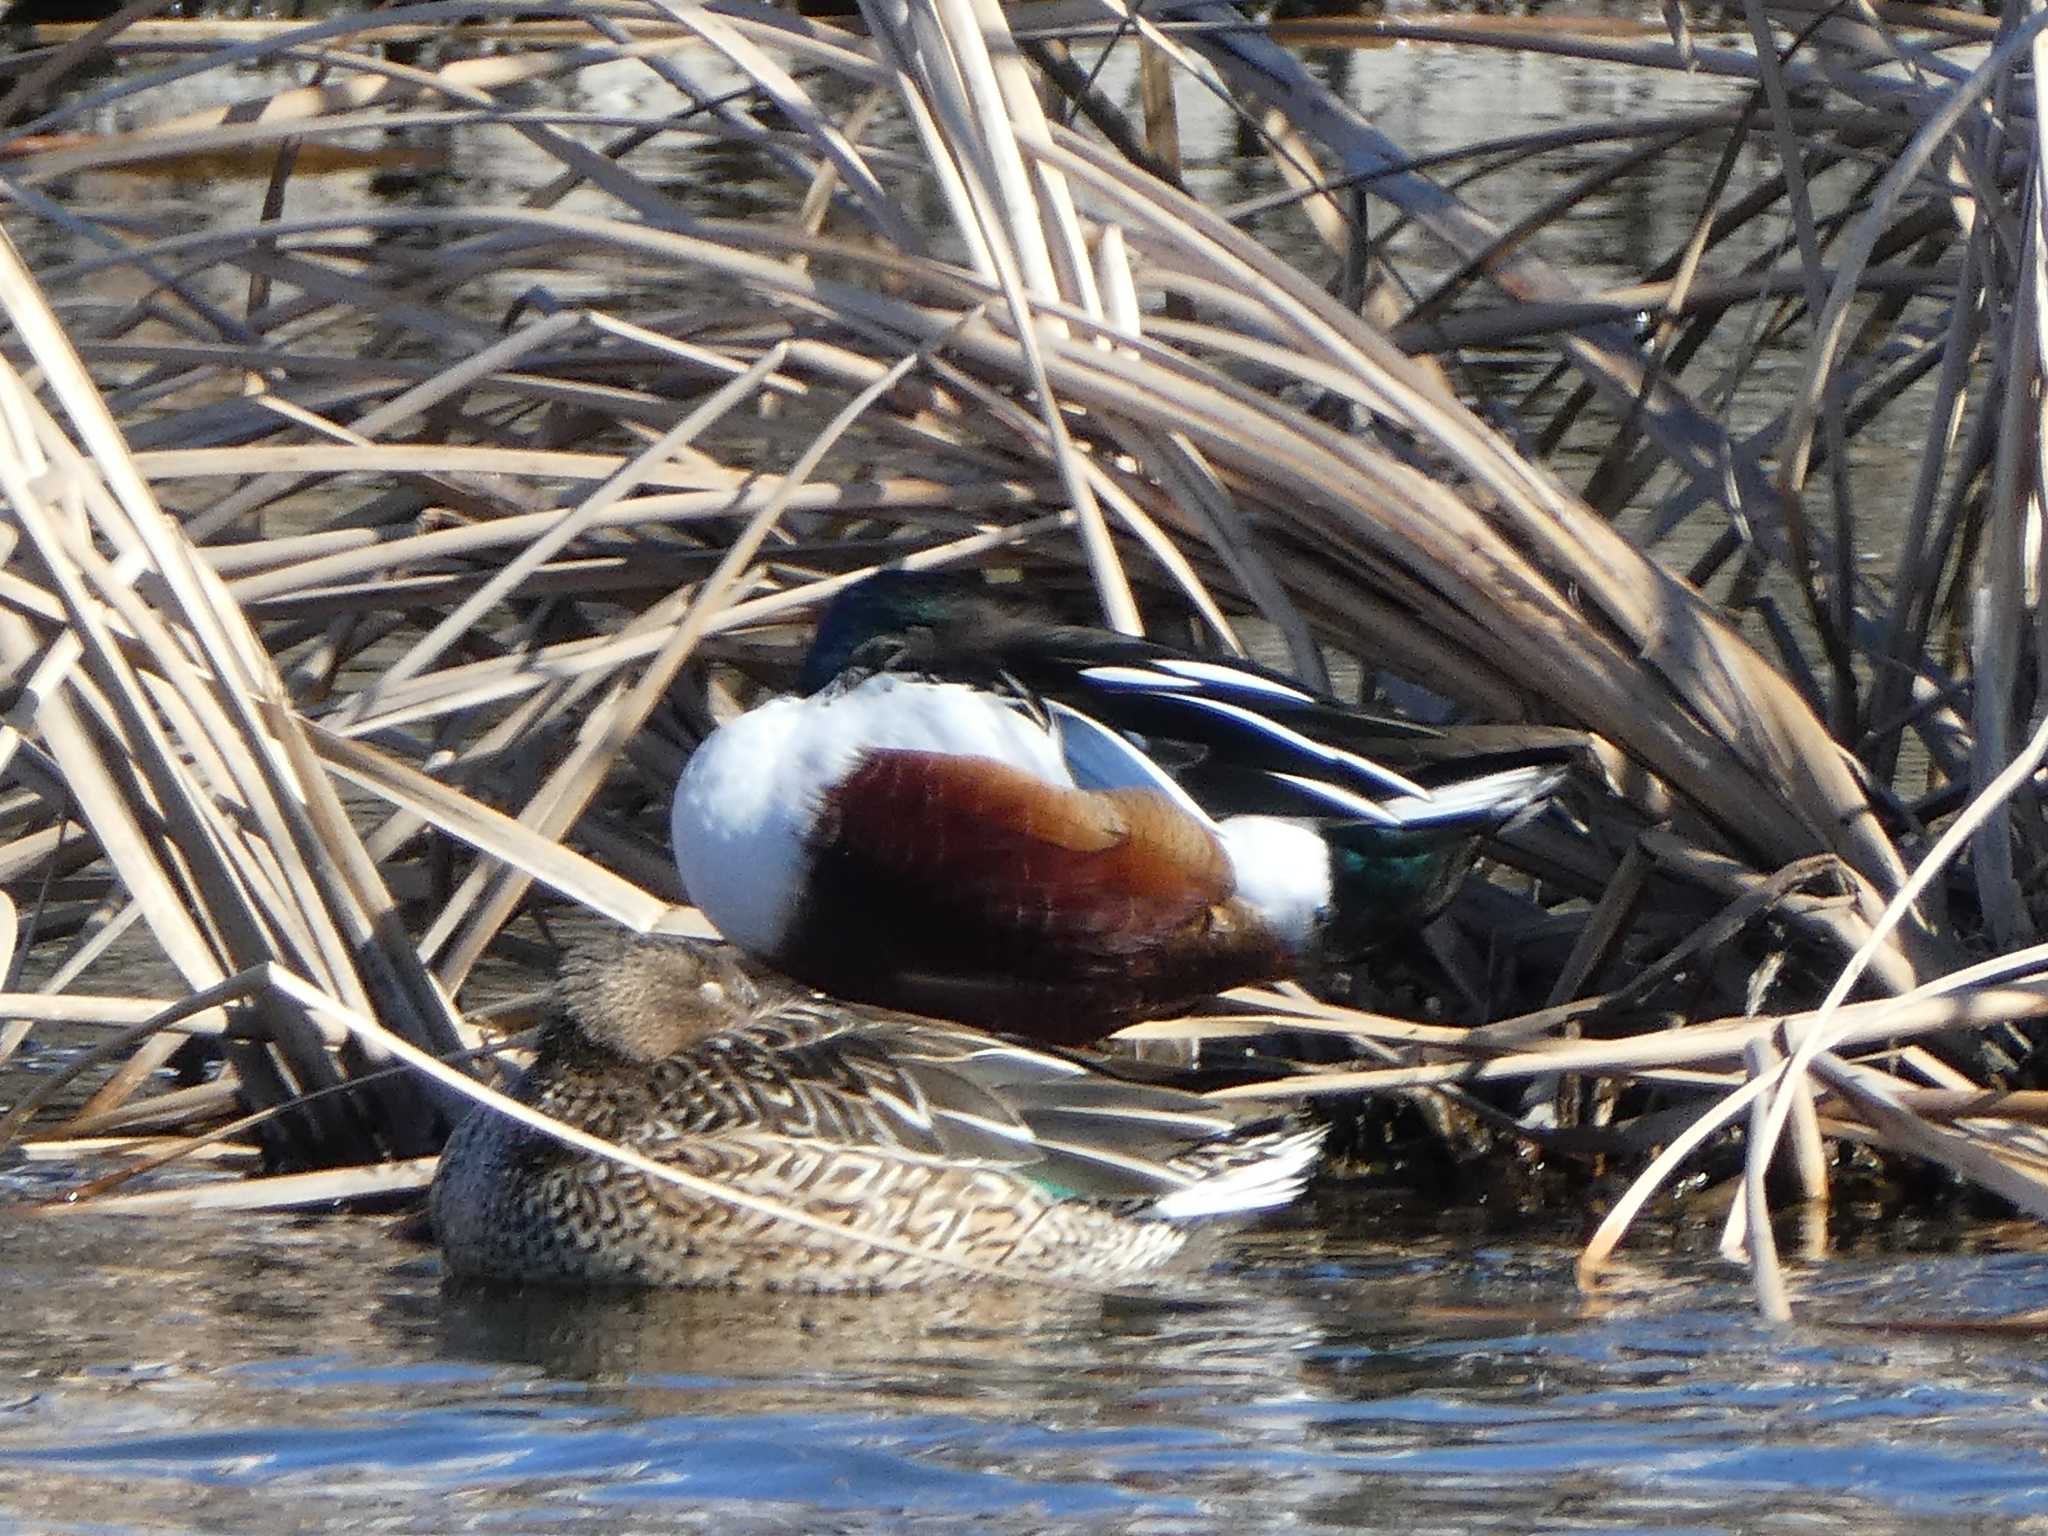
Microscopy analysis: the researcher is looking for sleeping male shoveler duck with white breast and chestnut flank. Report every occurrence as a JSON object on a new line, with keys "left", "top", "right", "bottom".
{"left": 672, "top": 571, "right": 1567, "bottom": 1044}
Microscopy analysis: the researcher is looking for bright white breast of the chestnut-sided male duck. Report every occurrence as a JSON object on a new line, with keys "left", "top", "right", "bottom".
{"left": 670, "top": 674, "right": 1073, "bottom": 956}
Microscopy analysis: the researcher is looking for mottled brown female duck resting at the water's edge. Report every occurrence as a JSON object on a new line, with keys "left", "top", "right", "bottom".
{"left": 430, "top": 938, "right": 1321, "bottom": 1290}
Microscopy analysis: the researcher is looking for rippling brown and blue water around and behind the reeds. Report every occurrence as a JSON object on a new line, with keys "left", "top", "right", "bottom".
{"left": 0, "top": 12, "right": 2048, "bottom": 1536}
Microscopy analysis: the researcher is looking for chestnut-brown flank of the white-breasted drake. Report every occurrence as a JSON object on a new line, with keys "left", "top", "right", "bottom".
{"left": 776, "top": 752, "right": 1290, "bottom": 1042}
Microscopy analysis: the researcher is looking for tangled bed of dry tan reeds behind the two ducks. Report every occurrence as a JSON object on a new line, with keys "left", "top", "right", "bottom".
{"left": 0, "top": 0, "right": 2048, "bottom": 1313}
